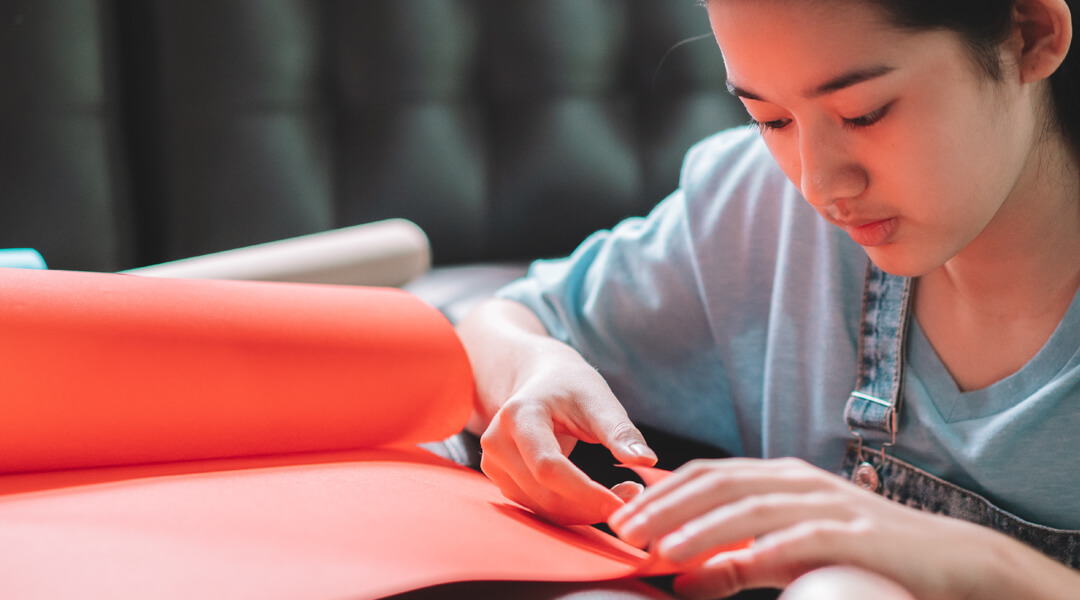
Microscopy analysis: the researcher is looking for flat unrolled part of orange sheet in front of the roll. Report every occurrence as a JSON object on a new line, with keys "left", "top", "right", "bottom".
{"left": 0, "top": 448, "right": 657, "bottom": 600}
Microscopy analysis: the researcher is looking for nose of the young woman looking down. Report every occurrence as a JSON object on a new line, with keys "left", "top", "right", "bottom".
{"left": 799, "top": 127, "right": 868, "bottom": 208}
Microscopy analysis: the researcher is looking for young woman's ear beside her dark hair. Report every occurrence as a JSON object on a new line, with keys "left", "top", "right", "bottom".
{"left": 1013, "top": 0, "right": 1072, "bottom": 83}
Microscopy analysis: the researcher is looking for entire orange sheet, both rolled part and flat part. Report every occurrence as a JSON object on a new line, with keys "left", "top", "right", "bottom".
{"left": 0, "top": 269, "right": 686, "bottom": 599}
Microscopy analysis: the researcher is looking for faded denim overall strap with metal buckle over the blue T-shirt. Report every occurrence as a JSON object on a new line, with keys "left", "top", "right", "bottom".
{"left": 843, "top": 262, "right": 913, "bottom": 442}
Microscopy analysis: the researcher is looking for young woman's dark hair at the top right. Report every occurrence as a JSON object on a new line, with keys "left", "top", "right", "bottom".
{"left": 869, "top": 0, "right": 1080, "bottom": 154}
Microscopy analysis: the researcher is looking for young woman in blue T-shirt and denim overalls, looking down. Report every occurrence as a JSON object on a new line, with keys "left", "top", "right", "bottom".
{"left": 459, "top": 0, "right": 1080, "bottom": 599}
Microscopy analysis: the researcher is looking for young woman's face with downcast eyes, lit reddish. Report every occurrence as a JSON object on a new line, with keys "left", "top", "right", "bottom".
{"left": 708, "top": 0, "right": 1037, "bottom": 276}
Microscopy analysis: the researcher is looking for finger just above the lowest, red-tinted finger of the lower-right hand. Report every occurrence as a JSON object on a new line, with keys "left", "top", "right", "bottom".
{"left": 656, "top": 492, "right": 850, "bottom": 562}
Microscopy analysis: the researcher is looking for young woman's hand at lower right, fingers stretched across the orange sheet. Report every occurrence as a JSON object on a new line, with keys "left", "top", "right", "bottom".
{"left": 609, "top": 459, "right": 1052, "bottom": 600}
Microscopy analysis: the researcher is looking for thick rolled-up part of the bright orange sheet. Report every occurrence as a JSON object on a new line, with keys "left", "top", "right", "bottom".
{"left": 0, "top": 269, "right": 473, "bottom": 473}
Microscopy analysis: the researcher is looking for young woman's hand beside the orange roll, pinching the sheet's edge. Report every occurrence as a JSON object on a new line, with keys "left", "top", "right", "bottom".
{"left": 458, "top": 300, "right": 657, "bottom": 524}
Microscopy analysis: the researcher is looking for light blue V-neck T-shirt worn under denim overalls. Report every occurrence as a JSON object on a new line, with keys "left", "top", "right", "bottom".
{"left": 500, "top": 127, "right": 1080, "bottom": 529}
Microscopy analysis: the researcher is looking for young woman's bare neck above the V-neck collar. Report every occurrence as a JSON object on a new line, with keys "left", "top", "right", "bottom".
{"left": 915, "top": 135, "right": 1080, "bottom": 391}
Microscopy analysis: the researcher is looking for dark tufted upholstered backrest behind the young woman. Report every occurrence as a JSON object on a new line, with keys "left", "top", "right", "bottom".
{"left": 0, "top": 0, "right": 745, "bottom": 271}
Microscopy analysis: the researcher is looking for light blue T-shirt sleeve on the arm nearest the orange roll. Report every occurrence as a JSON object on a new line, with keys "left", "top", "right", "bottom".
{"left": 499, "top": 137, "right": 735, "bottom": 441}
